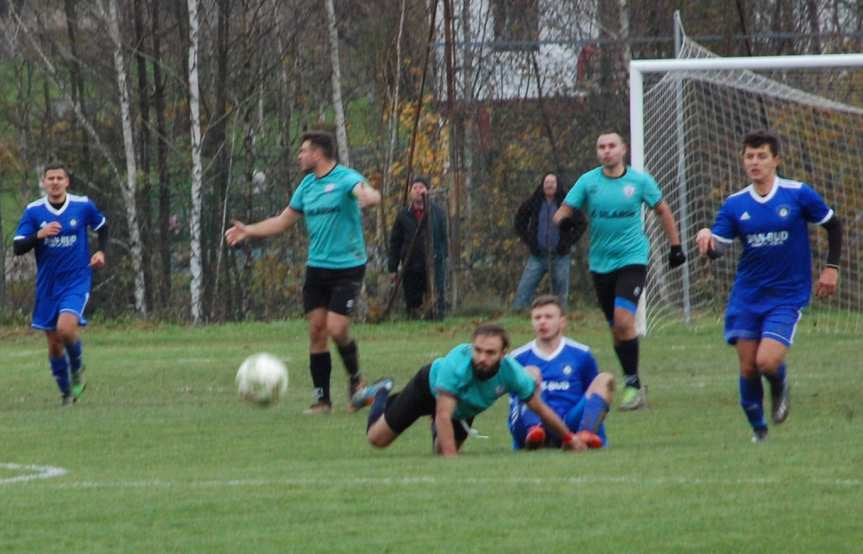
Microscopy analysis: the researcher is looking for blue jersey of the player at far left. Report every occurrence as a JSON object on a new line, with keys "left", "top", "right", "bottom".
{"left": 15, "top": 194, "right": 105, "bottom": 302}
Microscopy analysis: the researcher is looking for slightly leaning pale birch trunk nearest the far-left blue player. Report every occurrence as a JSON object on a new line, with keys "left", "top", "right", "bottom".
{"left": 100, "top": 0, "right": 147, "bottom": 315}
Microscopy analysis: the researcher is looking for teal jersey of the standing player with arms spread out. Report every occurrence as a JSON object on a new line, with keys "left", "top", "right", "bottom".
{"left": 290, "top": 165, "right": 367, "bottom": 269}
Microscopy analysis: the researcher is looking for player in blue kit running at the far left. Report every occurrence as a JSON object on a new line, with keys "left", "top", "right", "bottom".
{"left": 12, "top": 163, "right": 108, "bottom": 406}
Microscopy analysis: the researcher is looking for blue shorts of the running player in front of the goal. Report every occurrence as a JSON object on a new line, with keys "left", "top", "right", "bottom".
{"left": 725, "top": 304, "right": 802, "bottom": 348}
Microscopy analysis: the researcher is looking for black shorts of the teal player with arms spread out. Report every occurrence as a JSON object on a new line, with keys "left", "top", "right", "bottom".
{"left": 303, "top": 265, "right": 366, "bottom": 316}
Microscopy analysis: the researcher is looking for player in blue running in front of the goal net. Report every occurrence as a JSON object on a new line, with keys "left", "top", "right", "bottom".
{"left": 695, "top": 130, "right": 842, "bottom": 442}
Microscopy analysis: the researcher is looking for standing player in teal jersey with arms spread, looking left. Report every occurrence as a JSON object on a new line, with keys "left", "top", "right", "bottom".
{"left": 225, "top": 132, "right": 381, "bottom": 414}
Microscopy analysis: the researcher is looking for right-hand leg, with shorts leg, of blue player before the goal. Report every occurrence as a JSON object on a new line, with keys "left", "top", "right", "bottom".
{"left": 755, "top": 306, "right": 800, "bottom": 423}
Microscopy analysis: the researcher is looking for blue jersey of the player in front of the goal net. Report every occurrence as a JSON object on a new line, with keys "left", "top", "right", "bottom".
{"left": 711, "top": 177, "right": 833, "bottom": 312}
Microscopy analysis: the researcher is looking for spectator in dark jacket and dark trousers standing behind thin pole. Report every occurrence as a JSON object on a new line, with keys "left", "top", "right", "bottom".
{"left": 389, "top": 177, "right": 447, "bottom": 318}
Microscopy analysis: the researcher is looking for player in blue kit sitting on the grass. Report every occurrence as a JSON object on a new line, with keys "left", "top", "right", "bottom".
{"left": 509, "top": 295, "right": 614, "bottom": 450}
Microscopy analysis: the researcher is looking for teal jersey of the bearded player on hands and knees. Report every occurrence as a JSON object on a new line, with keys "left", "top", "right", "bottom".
{"left": 429, "top": 343, "right": 536, "bottom": 419}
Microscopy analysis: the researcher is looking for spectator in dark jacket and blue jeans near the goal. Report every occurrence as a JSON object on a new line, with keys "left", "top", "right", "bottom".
{"left": 513, "top": 173, "right": 587, "bottom": 310}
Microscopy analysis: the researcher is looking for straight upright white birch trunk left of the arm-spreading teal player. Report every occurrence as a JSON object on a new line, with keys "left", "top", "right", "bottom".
{"left": 188, "top": 0, "right": 203, "bottom": 325}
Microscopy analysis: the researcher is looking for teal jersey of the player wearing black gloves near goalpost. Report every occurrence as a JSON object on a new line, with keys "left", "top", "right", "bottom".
{"left": 563, "top": 166, "right": 662, "bottom": 273}
